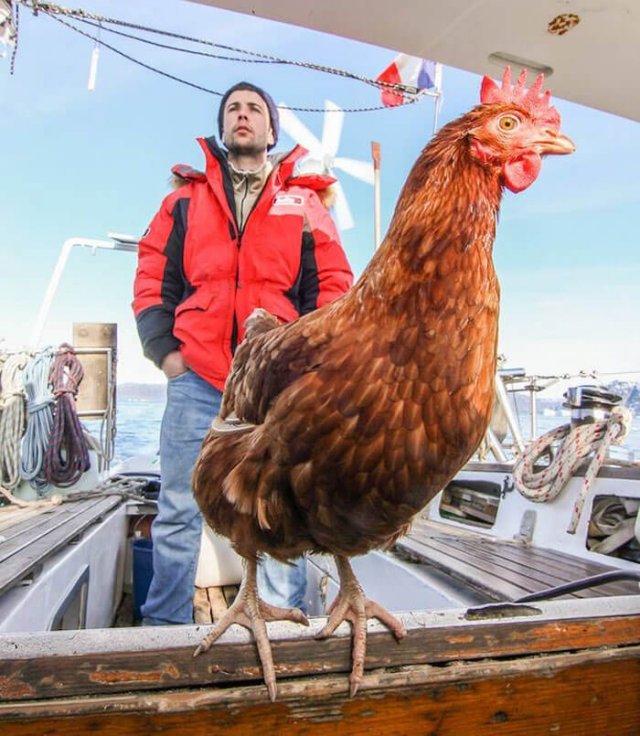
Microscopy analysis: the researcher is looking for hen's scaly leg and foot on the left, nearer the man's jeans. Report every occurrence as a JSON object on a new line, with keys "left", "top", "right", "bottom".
{"left": 193, "top": 560, "right": 309, "bottom": 701}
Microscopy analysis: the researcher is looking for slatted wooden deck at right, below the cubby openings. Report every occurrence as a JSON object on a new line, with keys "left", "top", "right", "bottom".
{"left": 396, "top": 519, "right": 640, "bottom": 601}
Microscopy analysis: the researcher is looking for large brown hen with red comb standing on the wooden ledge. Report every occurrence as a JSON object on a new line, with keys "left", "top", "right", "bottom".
{"left": 194, "top": 69, "right": 574, "bottom": 699}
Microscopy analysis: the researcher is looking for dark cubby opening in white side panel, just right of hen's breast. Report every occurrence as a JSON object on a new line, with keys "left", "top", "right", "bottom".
{"left": 439, "top": 480, "right": 502, "bottom": 528}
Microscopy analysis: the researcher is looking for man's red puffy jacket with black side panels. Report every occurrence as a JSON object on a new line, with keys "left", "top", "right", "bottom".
{"left": 133, "top": 138, "right": 353, "bottom": 390}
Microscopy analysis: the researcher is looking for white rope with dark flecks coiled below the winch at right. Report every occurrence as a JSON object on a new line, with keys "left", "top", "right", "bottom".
{"left": 513, "top": 406, "right": 631, "bottom": 534}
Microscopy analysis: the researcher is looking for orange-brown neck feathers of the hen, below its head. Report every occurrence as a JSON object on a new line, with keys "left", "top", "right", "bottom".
{"left": 356, "top": 107, "right": 502, "bottom": 306}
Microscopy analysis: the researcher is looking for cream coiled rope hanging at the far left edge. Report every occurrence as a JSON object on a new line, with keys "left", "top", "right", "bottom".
{"left": 0, "top": 353, "right": 29, "bottom": 489}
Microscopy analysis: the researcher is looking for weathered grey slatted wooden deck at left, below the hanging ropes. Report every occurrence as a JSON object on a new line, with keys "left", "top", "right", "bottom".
{"left": 0, "top": 495, "right": 122, "bottom": 594}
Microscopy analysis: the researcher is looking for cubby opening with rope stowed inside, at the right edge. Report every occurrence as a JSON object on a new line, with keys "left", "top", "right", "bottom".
{"left": 587, "top": 496, "right": 640, "bottom": 562}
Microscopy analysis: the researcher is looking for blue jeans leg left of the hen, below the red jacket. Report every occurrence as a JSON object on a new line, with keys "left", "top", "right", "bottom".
{"left": 141, "top": 371, "right": 222, "bottom": 625}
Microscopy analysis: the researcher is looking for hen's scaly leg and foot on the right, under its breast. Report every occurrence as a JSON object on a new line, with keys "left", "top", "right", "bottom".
{"left": 316, "top": 555, "right": 407, "bottom": 697}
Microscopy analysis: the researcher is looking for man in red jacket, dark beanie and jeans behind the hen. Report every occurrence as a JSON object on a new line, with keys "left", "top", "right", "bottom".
{"left": 133, "top": 82, "right": 353, "bottom": 624}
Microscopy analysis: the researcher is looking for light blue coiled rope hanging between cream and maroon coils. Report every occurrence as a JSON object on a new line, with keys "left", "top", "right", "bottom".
{"left": 20, "top": 349, "right": 54, "bottom": 496}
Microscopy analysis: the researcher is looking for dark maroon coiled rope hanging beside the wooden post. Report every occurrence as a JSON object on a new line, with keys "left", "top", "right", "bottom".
{"left": 43, "top": 343, "right": 91, "bottom": 488}
